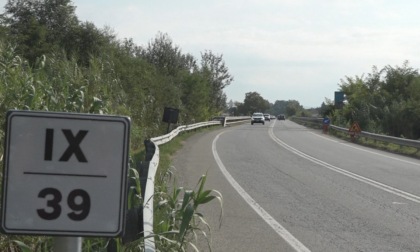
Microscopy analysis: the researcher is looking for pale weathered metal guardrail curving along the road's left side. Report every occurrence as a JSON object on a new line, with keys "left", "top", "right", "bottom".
{"left": 143, "top": 116, "right": 251, "bottom": 252}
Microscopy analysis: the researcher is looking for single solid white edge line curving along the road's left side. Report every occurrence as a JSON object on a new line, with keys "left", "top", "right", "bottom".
{"left": 212, "top": 132, "right": 310, "bottom": 252}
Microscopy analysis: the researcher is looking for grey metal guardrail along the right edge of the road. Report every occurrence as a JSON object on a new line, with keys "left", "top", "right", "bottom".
{"left": 295, "top": 117, "right": 420, "bottom": 149}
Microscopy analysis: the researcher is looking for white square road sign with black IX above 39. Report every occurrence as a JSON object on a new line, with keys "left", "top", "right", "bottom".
{"left": 1, "top": 111, "right": 130, "bottom": 237}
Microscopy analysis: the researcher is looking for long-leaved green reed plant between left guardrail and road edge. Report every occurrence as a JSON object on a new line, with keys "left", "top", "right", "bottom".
{"left": 155, "top": 175, "right": 223, "bottom": 251}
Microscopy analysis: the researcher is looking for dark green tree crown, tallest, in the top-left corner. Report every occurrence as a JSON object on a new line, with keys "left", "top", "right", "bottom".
{"left": 3, "top": 0, "right": 78, "bottom": 64}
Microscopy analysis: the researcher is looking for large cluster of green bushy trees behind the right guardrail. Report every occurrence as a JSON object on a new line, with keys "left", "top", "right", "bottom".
{"left": 320, "top": 61, "right": 420, "bottom": 139}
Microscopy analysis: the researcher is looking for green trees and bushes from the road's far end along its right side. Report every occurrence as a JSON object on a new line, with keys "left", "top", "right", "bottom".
{"left": 238, "top": 61, "right": 420, "bottom": 145}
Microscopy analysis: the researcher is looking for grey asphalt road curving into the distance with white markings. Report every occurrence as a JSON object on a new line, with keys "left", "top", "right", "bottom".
{"left": 173, "top": 120, "right": 420, "bottom": 252}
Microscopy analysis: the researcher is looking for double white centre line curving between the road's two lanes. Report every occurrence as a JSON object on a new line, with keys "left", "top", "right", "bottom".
{"left": 268, "top": 125, "right": 420, "bottom": 203}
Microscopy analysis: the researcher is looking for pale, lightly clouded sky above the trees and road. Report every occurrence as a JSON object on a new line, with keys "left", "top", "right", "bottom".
{"left": 0, "top": 0, "right": 420, "bottom": 108}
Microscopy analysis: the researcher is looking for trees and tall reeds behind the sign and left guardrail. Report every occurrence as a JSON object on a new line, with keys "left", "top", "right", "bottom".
{"left": 0, "top": 0, "right": 233, "bottom": 148}
